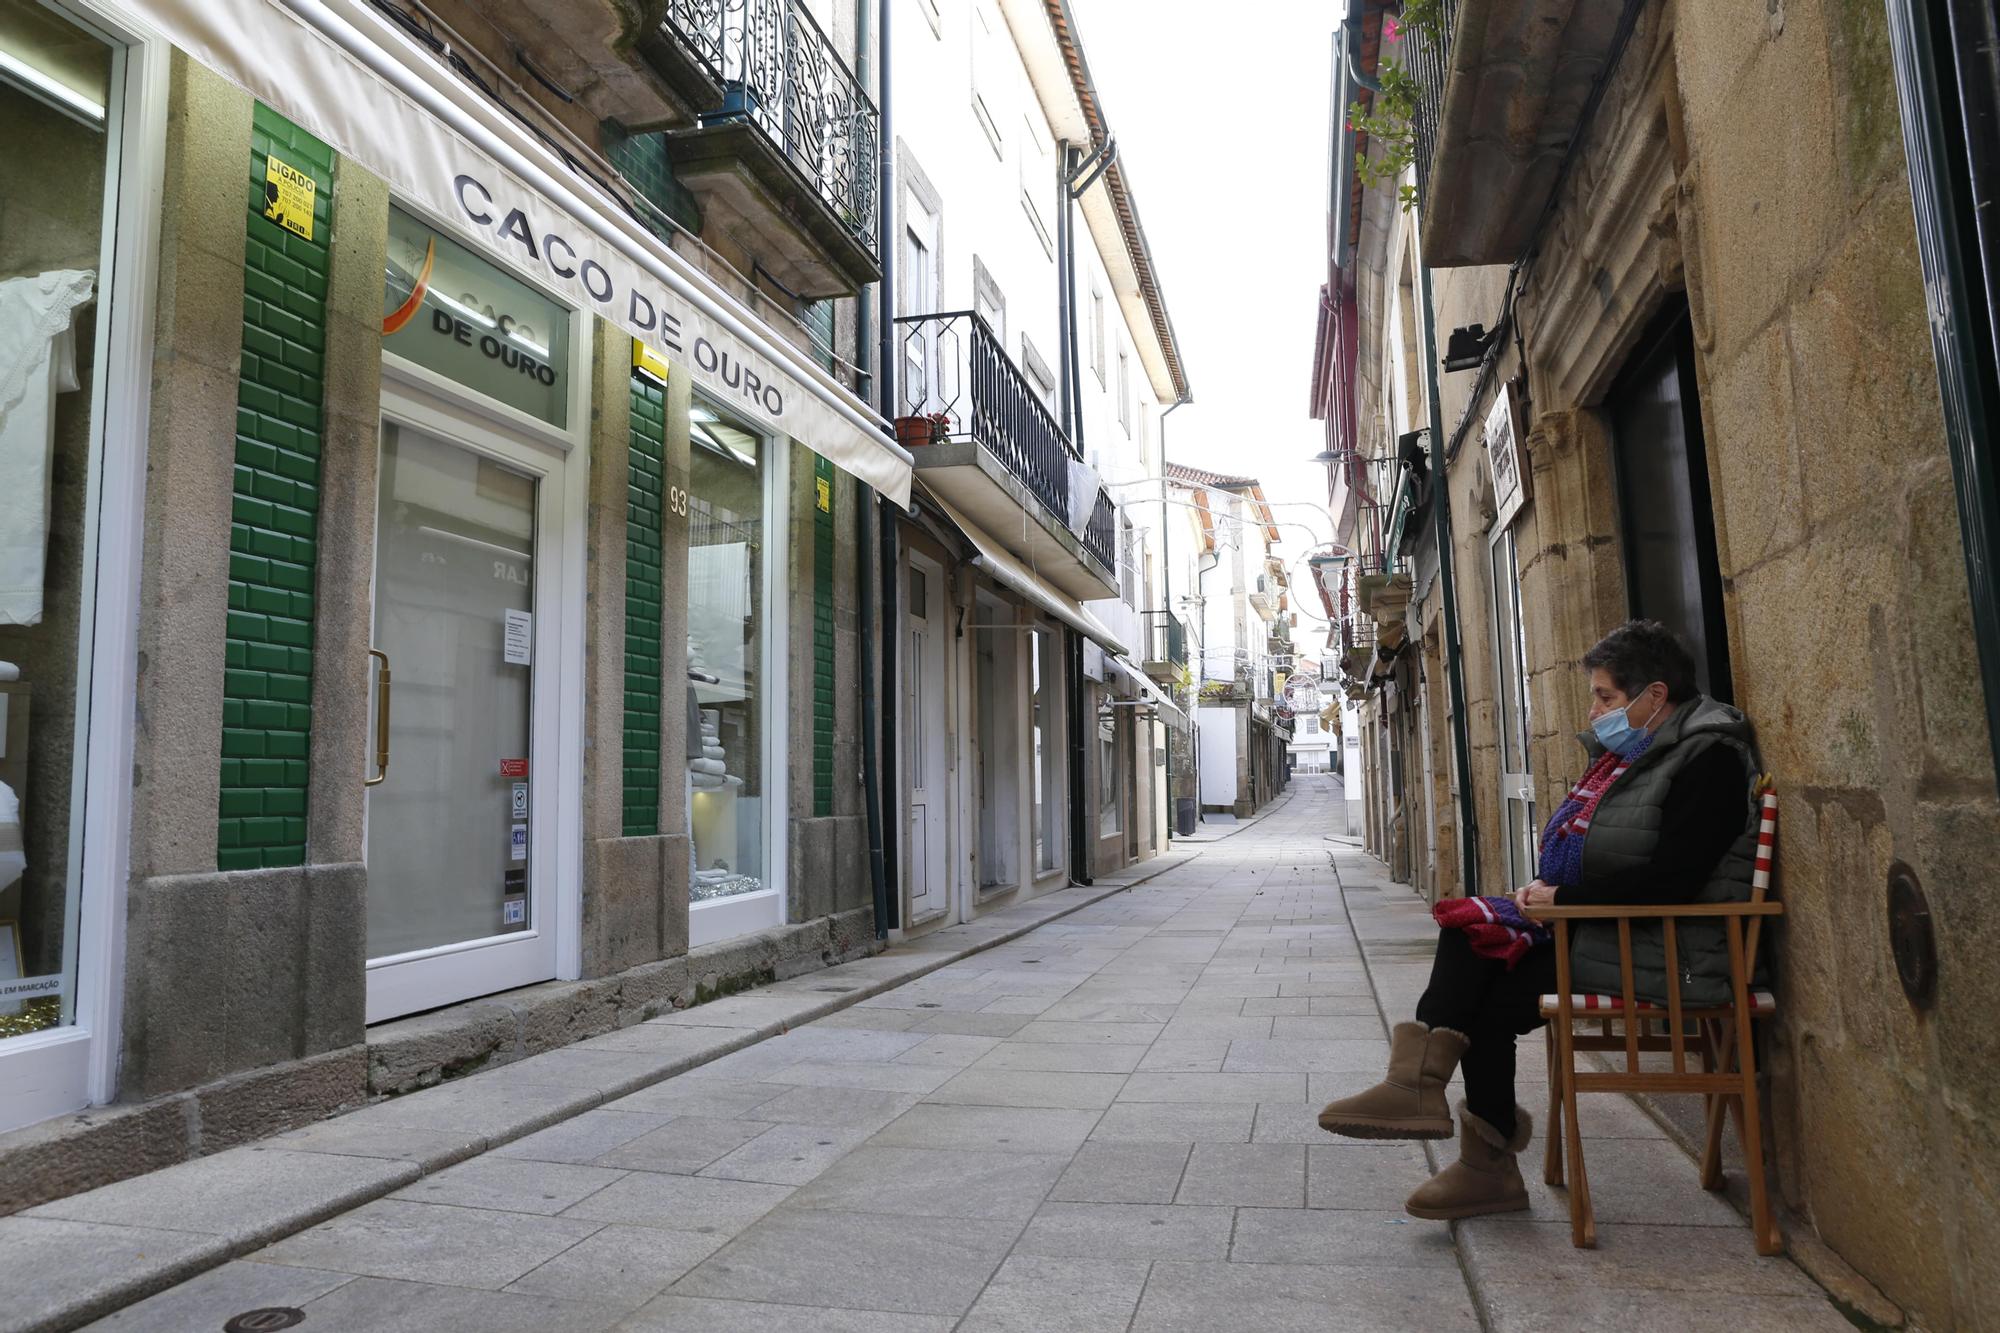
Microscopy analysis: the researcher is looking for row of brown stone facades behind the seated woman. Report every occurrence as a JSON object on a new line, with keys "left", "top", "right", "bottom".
{"left": 1316, "top": 0, "right": 2000, "bottom": 1329}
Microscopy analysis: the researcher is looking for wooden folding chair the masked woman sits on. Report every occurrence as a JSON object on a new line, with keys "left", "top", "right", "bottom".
{"left": 1528, "top": 783, "right": 1784, "bottom": 1255}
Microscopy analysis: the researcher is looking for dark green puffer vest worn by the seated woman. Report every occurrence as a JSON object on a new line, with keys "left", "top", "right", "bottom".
{"left": 1570, "top": 695, "right": 1762, "bottom": 1005}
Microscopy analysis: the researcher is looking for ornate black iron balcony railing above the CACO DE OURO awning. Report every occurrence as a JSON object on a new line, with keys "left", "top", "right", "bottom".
{"left": 662, "top": 0, "right": 882, "bottom": 254}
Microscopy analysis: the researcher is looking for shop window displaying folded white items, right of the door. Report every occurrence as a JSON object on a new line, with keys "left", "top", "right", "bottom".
{"left": 686, "top": 404, "right": 768, "bottom": 905}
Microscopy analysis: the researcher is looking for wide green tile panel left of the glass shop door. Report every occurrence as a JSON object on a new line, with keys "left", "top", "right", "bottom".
{"left": 216, "top": 106, "right": 334, "bottom": 871}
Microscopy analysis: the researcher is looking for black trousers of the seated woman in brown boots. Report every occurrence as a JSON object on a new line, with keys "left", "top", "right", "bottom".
{"left": 1416, "top": 931, "right": 1556, "bottom": 1135}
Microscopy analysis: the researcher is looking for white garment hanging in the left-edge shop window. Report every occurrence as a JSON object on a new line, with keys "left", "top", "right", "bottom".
{"left": 0, "top": 268, "right": 96, "bottom": 624}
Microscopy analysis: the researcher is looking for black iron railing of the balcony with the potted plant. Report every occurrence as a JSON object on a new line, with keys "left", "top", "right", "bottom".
{"left": 896, "top": 310, "right": 1118, "bottom": 570}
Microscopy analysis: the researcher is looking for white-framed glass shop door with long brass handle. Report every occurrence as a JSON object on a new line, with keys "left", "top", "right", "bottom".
{"left": 366, "top": 406, "right": 564, "bottom": 1023}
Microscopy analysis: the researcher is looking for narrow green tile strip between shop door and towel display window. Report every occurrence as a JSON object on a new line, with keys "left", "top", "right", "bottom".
{"left": 624, "top": 374, "right": 666, "bottom": 839}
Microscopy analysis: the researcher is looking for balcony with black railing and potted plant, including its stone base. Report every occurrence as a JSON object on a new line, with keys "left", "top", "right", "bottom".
{"left": 896, "top": 310, "right": 1120, "bottom": 600}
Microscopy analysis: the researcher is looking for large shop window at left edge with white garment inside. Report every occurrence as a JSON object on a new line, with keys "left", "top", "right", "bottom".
{"left": 0, "top": 0, "right": 122, "bottom": 1040}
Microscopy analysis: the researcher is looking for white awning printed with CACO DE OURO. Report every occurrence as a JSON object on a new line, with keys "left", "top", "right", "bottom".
{"left": 116, "top": 0, "right": 910, "bottom": 504}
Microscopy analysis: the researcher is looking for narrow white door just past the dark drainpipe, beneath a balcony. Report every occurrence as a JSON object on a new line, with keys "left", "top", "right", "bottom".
{"left": 902, "top": 552, "right": 952, "bottom": 923}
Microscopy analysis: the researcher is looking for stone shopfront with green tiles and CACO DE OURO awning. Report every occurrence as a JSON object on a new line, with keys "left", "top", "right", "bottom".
{"left": 0, "top": 0, "right": 910, "bottom": 1211}
